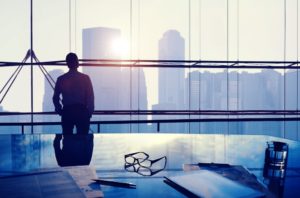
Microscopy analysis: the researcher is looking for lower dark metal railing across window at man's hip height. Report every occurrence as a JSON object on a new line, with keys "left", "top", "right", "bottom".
{"left": 0, "top": 110, "right": 300, "bottom": 134}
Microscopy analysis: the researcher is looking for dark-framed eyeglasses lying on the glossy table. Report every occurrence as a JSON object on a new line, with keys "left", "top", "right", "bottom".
{"left": 124, "top": 152, "right": 167, "bottom": 176}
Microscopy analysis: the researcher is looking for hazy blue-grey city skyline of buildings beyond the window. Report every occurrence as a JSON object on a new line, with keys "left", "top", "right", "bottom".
{"left": 2, "top": 27, "right": 299, "bottom": 139}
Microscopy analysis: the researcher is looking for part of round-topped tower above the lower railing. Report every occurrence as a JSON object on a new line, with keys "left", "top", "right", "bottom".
{"left": 158, "top": 30, "right": 185, "bottom": 109}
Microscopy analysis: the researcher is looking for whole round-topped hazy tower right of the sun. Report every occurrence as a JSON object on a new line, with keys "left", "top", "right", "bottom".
{"left": 152, "top": 30, "right": 186, "bottom": 133}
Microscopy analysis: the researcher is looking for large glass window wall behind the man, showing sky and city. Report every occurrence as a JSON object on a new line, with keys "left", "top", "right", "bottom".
{"left": 0, "top": 0, "right": 300, "bottom": 139}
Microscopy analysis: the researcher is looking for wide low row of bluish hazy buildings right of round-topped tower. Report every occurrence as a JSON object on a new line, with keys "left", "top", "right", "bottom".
{"left": 185, "top": 70, "right": 284, "bottom": 135}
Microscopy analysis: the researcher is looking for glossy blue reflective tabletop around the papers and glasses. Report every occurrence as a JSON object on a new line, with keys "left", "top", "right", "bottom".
{"left": 0, "top": 133, "right": 300, "bottom": 197}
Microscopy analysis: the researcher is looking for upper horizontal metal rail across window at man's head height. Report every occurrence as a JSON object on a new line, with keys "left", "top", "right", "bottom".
{"left": 0, "top": 59, "right": 300, "bottom": 69}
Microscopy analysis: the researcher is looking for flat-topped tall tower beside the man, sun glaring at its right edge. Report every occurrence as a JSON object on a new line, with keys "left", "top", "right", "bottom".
{"left": 82, "top": 27, "right": 121, "bottom": 110}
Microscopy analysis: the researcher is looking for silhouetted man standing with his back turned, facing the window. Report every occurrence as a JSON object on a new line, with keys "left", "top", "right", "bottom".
{"left": 53, "top": 53, "right": 94, "bottom": 134}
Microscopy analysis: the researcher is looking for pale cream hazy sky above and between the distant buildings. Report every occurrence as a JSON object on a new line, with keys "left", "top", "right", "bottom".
{"left": 0, "top": 0, "right": 297, "bottom": 111}
